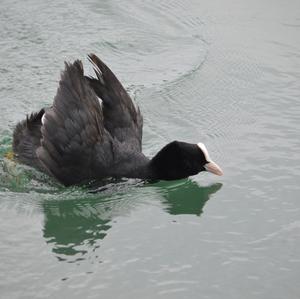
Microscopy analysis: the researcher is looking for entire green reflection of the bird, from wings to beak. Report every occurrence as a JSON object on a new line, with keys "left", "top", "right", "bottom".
{"left": 43, "top": 180, "right": 222, "bottom": 262}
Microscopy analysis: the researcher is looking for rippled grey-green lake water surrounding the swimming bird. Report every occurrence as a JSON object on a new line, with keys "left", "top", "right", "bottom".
{"left": 0, "top": 0, "right": 300, "bottom": 299}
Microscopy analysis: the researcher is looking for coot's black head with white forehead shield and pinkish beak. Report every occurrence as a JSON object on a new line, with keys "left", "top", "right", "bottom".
{"left": 151, "top": 141, "right": 223, "bottom": 180}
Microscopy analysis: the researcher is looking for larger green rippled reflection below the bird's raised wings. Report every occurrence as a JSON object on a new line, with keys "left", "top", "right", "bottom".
{"left": 43, "top": 198, "right": 115, "bottom": 262}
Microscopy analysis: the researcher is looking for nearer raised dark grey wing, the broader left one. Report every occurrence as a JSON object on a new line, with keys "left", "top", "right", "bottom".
{"left": 36, "top": 60, "right": 112, "bottom": 185}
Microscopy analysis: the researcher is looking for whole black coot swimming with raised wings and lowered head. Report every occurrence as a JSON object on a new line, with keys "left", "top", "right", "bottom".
{"left": 13, "top": 54, "right": 222, "bottom": 186}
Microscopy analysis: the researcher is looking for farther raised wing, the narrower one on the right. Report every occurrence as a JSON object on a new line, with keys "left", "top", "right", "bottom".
{"left": 86, "top": 54, "right": 143, "bottom": 151}
